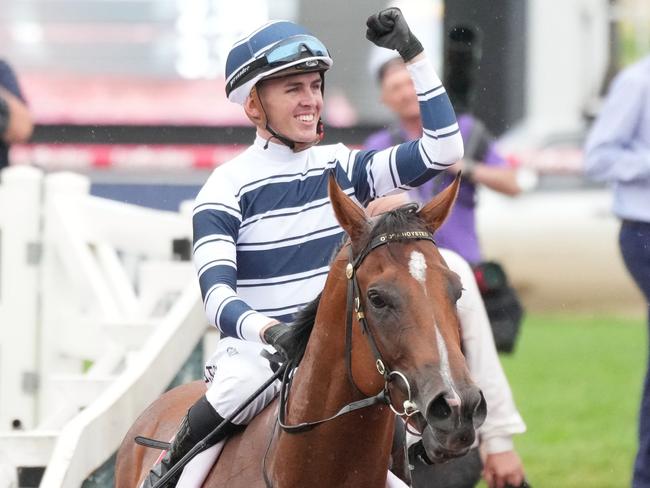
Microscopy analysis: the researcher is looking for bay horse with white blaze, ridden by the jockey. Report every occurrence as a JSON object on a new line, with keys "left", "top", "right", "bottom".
{"left": 115, "top": 176, "right": 486, "bottom": 488}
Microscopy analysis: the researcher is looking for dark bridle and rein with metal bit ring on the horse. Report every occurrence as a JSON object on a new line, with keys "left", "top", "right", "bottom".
{"left": 278, "top": 231, "right": 435, "bottom": 434}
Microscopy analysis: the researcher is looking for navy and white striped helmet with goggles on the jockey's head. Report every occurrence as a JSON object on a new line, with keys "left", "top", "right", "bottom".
{"left": 226, "top": 20, "right": 333, "bottom": 105}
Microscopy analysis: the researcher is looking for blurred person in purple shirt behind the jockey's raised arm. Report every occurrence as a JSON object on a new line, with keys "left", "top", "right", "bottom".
{"left": 364, "top": 26, "right": 529, "bottom": 264}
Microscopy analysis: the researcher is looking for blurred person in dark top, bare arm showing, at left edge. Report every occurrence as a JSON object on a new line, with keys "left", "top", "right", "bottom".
{"left": 0, "top": 59, "right": 34, "bottom": 169}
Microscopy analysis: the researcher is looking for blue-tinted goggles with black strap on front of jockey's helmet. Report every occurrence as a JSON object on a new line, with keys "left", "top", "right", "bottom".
{"left": 226, "top": 35, "right": 331, "bottom": 99}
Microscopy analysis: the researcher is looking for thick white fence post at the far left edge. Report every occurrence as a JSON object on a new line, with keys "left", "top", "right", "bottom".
{"left": 0, "top": 166, "right": 43, "bottom": 431}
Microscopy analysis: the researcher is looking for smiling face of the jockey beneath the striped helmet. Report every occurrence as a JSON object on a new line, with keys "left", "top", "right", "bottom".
{"left": 257, "top": 72, "right": 323, "bottom": 142}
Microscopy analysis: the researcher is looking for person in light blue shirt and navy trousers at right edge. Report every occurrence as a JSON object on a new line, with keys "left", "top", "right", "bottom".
{"left": 585, "top": 56, "right": 650, "bottom": 488}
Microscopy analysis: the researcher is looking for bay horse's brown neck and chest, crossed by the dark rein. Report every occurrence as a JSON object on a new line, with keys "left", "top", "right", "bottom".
{"left": 266, "top": 264, "right": 393, "bottom": 488}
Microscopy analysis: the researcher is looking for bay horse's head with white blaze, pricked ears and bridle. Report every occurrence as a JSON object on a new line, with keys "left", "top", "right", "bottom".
{"left": 329, "top": 174, "right": 487, "bottom": 461}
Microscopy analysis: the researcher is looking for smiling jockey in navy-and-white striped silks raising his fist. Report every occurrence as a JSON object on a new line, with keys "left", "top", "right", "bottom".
{"left": 143, "top": 8, "right": 463, "bottom": 488}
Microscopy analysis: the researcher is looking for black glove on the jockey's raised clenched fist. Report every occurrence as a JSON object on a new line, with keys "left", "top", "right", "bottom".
{"left": 366, "top": 7, "right": 424, "bottom": 62}
